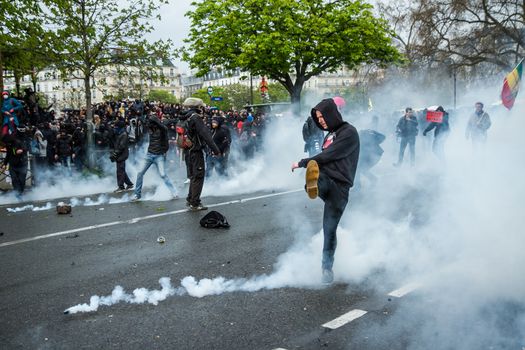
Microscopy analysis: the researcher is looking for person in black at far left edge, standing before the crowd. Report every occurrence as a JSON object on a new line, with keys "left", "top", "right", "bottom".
{"left": 1, "top": 134, "right": 27, "bottom": 200}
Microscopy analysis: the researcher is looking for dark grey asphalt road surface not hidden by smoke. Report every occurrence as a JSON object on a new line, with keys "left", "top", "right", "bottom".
{"left": 0, "top": 185, "right": 513, "bottom": 349}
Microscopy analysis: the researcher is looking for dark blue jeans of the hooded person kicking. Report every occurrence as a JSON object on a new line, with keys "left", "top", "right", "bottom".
{"left": 317, "top": 172, "right": 350, "bottom": 270}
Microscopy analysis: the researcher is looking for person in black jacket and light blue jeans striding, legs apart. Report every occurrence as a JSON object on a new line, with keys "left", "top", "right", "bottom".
{"left": 132, "top": 114, "right": 179, "bottom": 201}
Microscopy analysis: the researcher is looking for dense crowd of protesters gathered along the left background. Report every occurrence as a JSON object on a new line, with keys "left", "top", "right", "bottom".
{"left": 0, "top": 89, "right": 267, "bottom": 196}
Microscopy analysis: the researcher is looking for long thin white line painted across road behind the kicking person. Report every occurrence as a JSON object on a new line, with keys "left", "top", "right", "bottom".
{"left": 0, "top": 190, "right": 303, "bottom": 248}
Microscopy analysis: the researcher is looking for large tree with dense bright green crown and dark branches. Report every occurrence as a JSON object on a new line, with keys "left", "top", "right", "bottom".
{"left": 182, "top": 0, "right": 401, "bottom": 108}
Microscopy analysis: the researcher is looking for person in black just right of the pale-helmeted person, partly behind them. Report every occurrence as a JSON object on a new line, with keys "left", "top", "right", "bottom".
{"left": 206, "top": 116, "right": 232, "bottom": 177}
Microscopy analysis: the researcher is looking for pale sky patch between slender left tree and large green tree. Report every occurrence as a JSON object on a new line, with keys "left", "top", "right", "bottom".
{"left": 149, "top": 0, "right": 193, "bottom": 73}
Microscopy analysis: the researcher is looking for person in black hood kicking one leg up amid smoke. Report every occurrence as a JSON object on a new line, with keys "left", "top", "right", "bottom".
{"left": 292, "top": 98, "right": 359, "bottom": 284}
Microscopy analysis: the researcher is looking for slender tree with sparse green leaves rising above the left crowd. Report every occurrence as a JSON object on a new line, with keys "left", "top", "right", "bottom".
{"left": 45, "top": 0, "right": 169, "bottom": 165}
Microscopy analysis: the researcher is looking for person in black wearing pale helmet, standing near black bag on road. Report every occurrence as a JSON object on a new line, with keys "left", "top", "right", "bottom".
{"left": 179, "top": 97, "right": 221, "bottom": 210}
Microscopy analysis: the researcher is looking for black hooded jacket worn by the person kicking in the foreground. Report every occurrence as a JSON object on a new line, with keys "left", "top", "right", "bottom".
{"left": 299, "top": 98, "right": 359, "bottom": 187}
